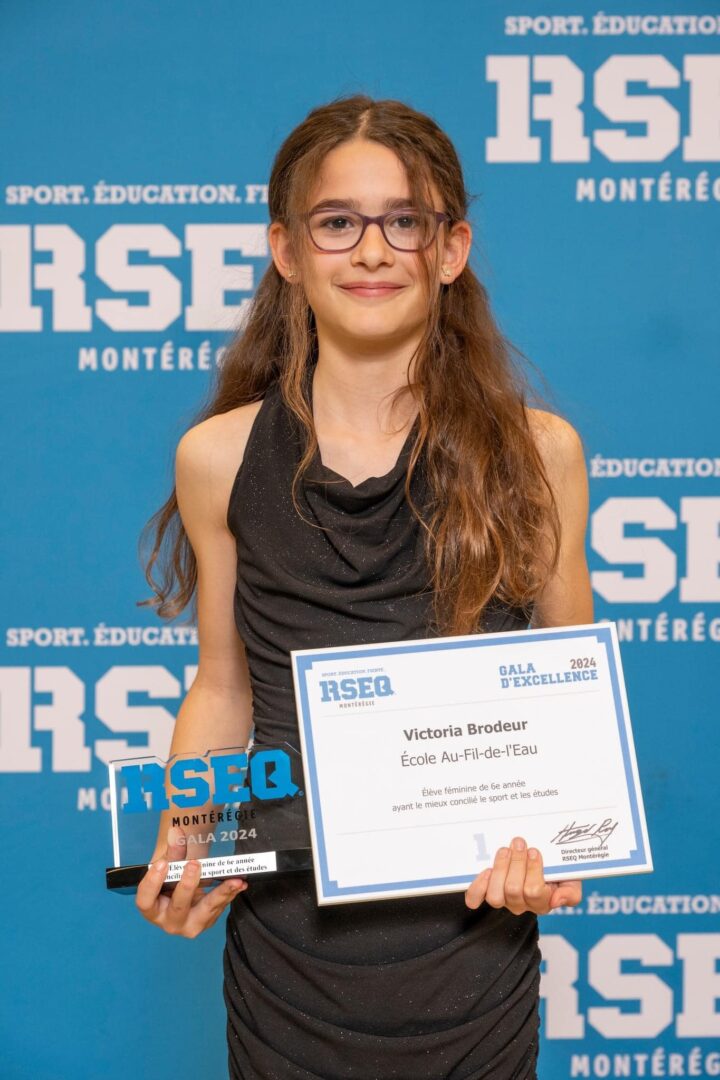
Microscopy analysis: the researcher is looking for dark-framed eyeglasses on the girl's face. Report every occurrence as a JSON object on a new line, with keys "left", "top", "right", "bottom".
{"left": 307, "top": 207, "right": 450, "bottom": 252}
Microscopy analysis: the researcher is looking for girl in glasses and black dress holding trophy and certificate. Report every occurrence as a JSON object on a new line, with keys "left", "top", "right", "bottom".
{"left": 137, "top": 96, "right": 593, "bottom": 1080}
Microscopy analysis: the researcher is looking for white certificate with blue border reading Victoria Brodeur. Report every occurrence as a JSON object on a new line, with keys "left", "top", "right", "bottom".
{"left": 290, "top": 623, "right": 652, "bottom": 905}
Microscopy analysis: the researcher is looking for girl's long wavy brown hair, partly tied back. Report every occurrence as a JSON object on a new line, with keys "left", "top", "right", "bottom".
{"left": 140, "top": 95, "right": 559, "bottom": 635}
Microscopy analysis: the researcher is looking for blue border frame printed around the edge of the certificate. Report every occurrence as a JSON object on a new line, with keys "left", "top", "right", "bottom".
{"left": 293, "top": 626, "right": 648, "bottom": 897}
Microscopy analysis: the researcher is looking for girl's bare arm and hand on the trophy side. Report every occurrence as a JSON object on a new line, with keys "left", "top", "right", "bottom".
{"left": 136, "top": 403, "right": 259, "bottom": 937}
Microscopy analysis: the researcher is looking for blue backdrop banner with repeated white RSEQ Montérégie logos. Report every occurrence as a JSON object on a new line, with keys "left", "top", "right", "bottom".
{"left": 0, "top": 0, "right": 720, "bottom": 1080}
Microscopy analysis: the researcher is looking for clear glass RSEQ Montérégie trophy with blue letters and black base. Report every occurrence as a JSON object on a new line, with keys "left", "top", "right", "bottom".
{"left": 106, "top": 743, "right": 312, "bottom": 892}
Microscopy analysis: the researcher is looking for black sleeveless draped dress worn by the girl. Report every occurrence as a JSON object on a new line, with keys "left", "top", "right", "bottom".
{"left": 223, "top": 381, "right": 540, "bottom": 1080}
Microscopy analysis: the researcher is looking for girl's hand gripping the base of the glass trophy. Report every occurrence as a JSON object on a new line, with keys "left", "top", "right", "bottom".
{"left": 135, "top": 826, "right": 247, "bottom": 937}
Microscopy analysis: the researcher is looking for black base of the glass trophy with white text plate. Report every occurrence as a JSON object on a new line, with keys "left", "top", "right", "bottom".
{"left": 105, "top": 848, "right": 313, "bottom": 893}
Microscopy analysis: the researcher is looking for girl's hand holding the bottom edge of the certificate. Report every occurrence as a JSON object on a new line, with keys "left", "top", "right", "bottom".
{"left": 465, "top": 836, "right": 583, "bottom": 915}
